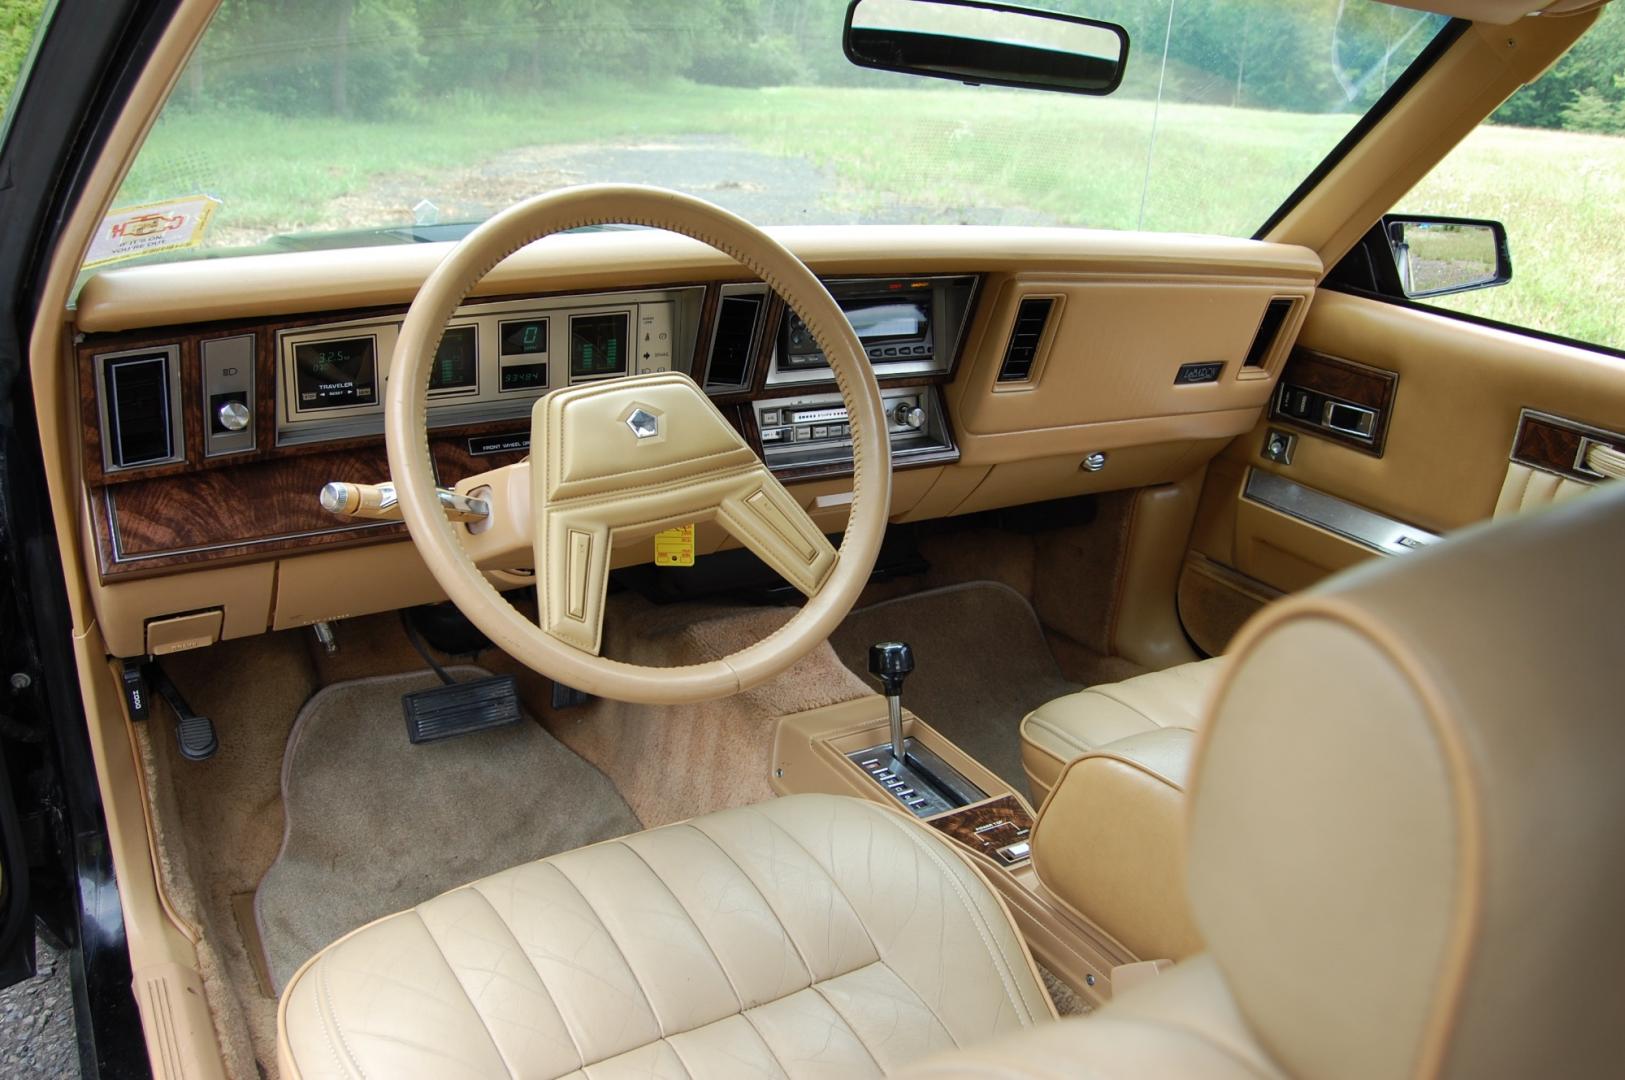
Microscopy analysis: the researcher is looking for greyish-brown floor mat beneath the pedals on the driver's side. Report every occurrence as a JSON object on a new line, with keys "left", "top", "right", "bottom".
{"left": 254, "top": 666, "right": 640, "bottom": 991}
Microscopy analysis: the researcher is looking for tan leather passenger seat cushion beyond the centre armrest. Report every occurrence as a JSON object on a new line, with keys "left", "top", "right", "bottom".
{"left": 1021, "top": 656, "right": 1225, "bottom": 802}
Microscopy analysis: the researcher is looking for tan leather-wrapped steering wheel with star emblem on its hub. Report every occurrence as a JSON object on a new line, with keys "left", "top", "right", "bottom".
{"left": 384, "top": 184, "right": 892, "bottom": 705}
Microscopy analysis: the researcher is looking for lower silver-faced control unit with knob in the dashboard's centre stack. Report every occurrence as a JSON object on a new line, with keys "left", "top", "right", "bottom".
{"left": 752, "top": 387, "right": 954, "bottom": 469}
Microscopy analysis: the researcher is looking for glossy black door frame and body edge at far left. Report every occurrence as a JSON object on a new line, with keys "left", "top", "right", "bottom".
{"left": 0, "top": 0, "right": 191, "bottom": 1077}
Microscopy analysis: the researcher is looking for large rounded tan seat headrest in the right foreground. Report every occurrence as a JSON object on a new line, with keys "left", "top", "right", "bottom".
{"left": 1188, "top": 482, "right": 1625, "bottom": 1078}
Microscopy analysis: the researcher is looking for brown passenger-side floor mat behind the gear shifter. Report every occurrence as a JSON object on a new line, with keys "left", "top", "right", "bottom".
{"left": 830, "top": 581, "right": 1082, "bottom": 793}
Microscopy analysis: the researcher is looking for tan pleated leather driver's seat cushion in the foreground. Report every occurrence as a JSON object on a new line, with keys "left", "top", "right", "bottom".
{"left": 278, "top": 796, "right": 1055, "bottom": 1078}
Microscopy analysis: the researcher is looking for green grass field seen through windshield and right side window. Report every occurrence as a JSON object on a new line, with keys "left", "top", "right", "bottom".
{"left": 120, "top": 83, "right": 1625, "bottom": 346}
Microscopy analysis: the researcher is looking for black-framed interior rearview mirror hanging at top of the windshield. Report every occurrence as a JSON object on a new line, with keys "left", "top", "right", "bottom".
{"left": 842, "top": 0, "right": 1128, "bottom": 94}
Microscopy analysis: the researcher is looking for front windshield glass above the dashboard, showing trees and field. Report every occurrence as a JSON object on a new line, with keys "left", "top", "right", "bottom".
{"left": 98, "top": 0, "right": 1445, "bottom": 266}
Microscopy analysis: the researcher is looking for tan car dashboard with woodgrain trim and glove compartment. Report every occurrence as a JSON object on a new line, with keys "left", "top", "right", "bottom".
{"left": 72, "top": 227, "right": 1320, "bottom": 656}
